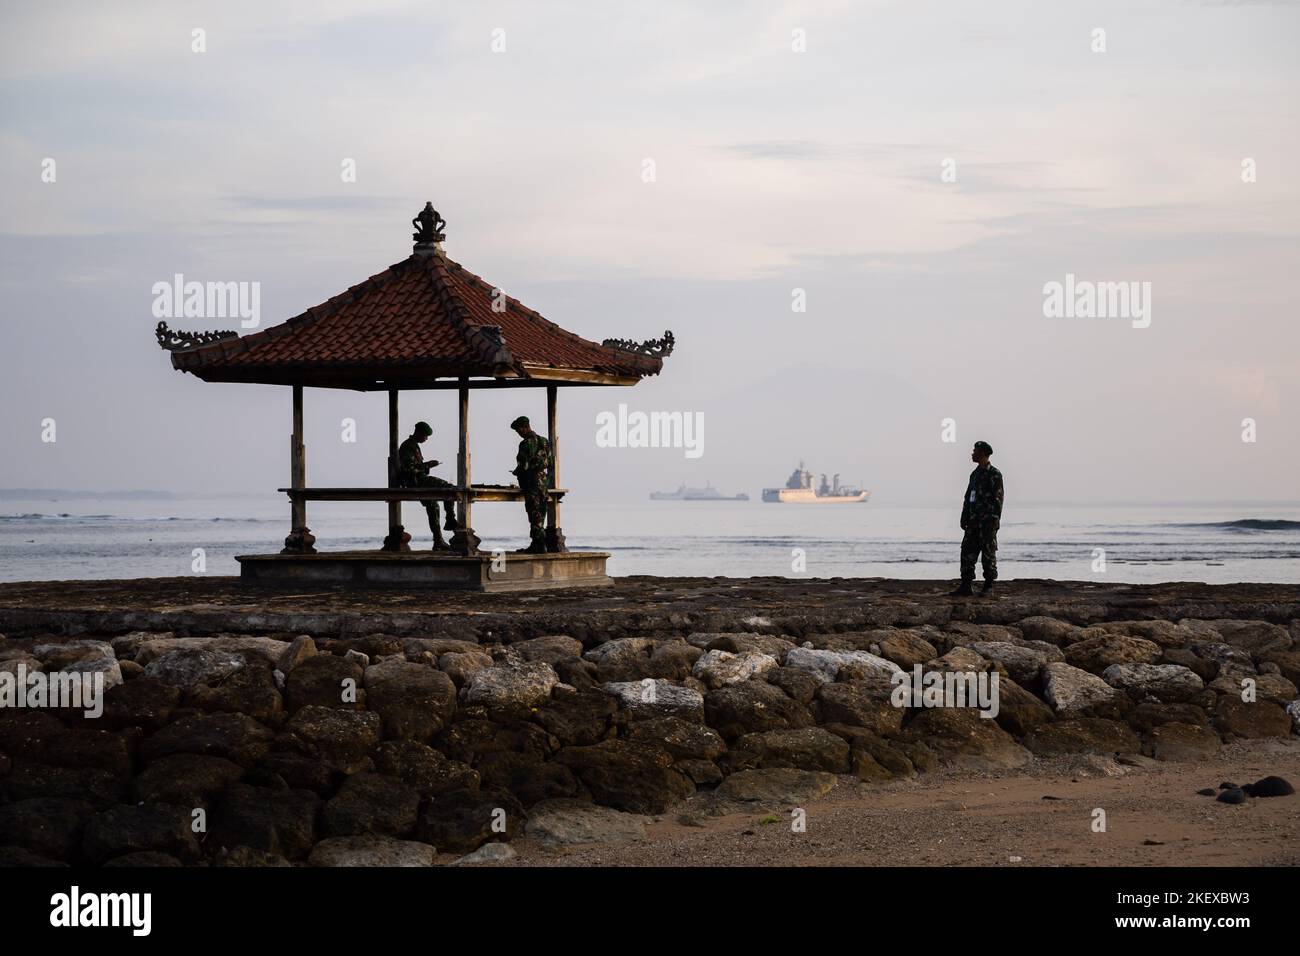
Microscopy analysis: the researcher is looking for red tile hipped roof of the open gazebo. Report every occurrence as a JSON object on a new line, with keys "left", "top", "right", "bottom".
{"left": 163, "top": 250, "right": 663, "bottom": 389}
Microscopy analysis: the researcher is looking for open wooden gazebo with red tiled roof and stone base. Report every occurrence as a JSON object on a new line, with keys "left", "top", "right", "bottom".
{"left": 156, "top": 203, "right": 673, "bottom": 588}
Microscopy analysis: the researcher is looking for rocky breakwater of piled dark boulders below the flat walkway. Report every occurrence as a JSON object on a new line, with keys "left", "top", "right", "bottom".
{"left": 0, "top": 583, "right": 1300, "bottom": 866}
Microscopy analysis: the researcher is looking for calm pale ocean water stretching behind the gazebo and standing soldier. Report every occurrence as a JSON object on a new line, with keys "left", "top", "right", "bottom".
{"left": 0, "top": 494, "right": 1300, "bottom": 584}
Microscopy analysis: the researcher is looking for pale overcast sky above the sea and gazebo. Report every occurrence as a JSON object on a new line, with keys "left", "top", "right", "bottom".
{"left": 0, "top": 0, "right": 1300, "bottom": 502}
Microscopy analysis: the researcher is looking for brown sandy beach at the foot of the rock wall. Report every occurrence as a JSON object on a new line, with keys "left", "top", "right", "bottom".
{"left": 499, "top": 740, "right": 1300, "bottom": 866}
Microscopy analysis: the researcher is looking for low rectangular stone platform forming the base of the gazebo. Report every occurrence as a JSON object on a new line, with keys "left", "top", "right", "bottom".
{"left": 235, "top": 551, "right": 614, "bottom": 592}
